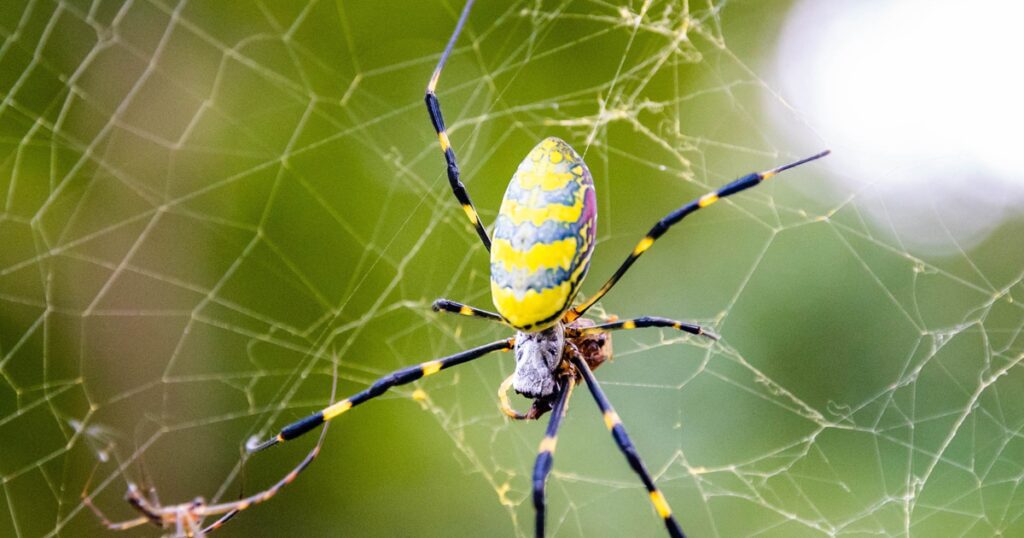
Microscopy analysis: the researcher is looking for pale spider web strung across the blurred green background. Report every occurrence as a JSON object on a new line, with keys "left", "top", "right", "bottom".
{"left": 0, "top": 0, "right": 1024, "bottom": 536}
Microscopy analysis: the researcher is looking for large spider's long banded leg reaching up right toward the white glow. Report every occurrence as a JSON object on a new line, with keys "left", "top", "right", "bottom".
{"left": 564, "top": 151, "right": 830, "bottom": 322}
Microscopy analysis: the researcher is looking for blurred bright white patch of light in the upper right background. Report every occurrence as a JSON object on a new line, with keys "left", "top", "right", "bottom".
{"left": 769, "top": 0, "right": 1024, "bottom": 250}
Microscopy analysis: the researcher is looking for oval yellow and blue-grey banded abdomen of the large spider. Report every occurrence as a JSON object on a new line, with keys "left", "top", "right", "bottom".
{"left": 490, "top": 137, "right": 597, "bottom": 332}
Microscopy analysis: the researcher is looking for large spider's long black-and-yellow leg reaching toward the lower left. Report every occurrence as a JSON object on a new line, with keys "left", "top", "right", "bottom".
{"left": 249, "top": 338, "right": 515, "bottom": 452}
